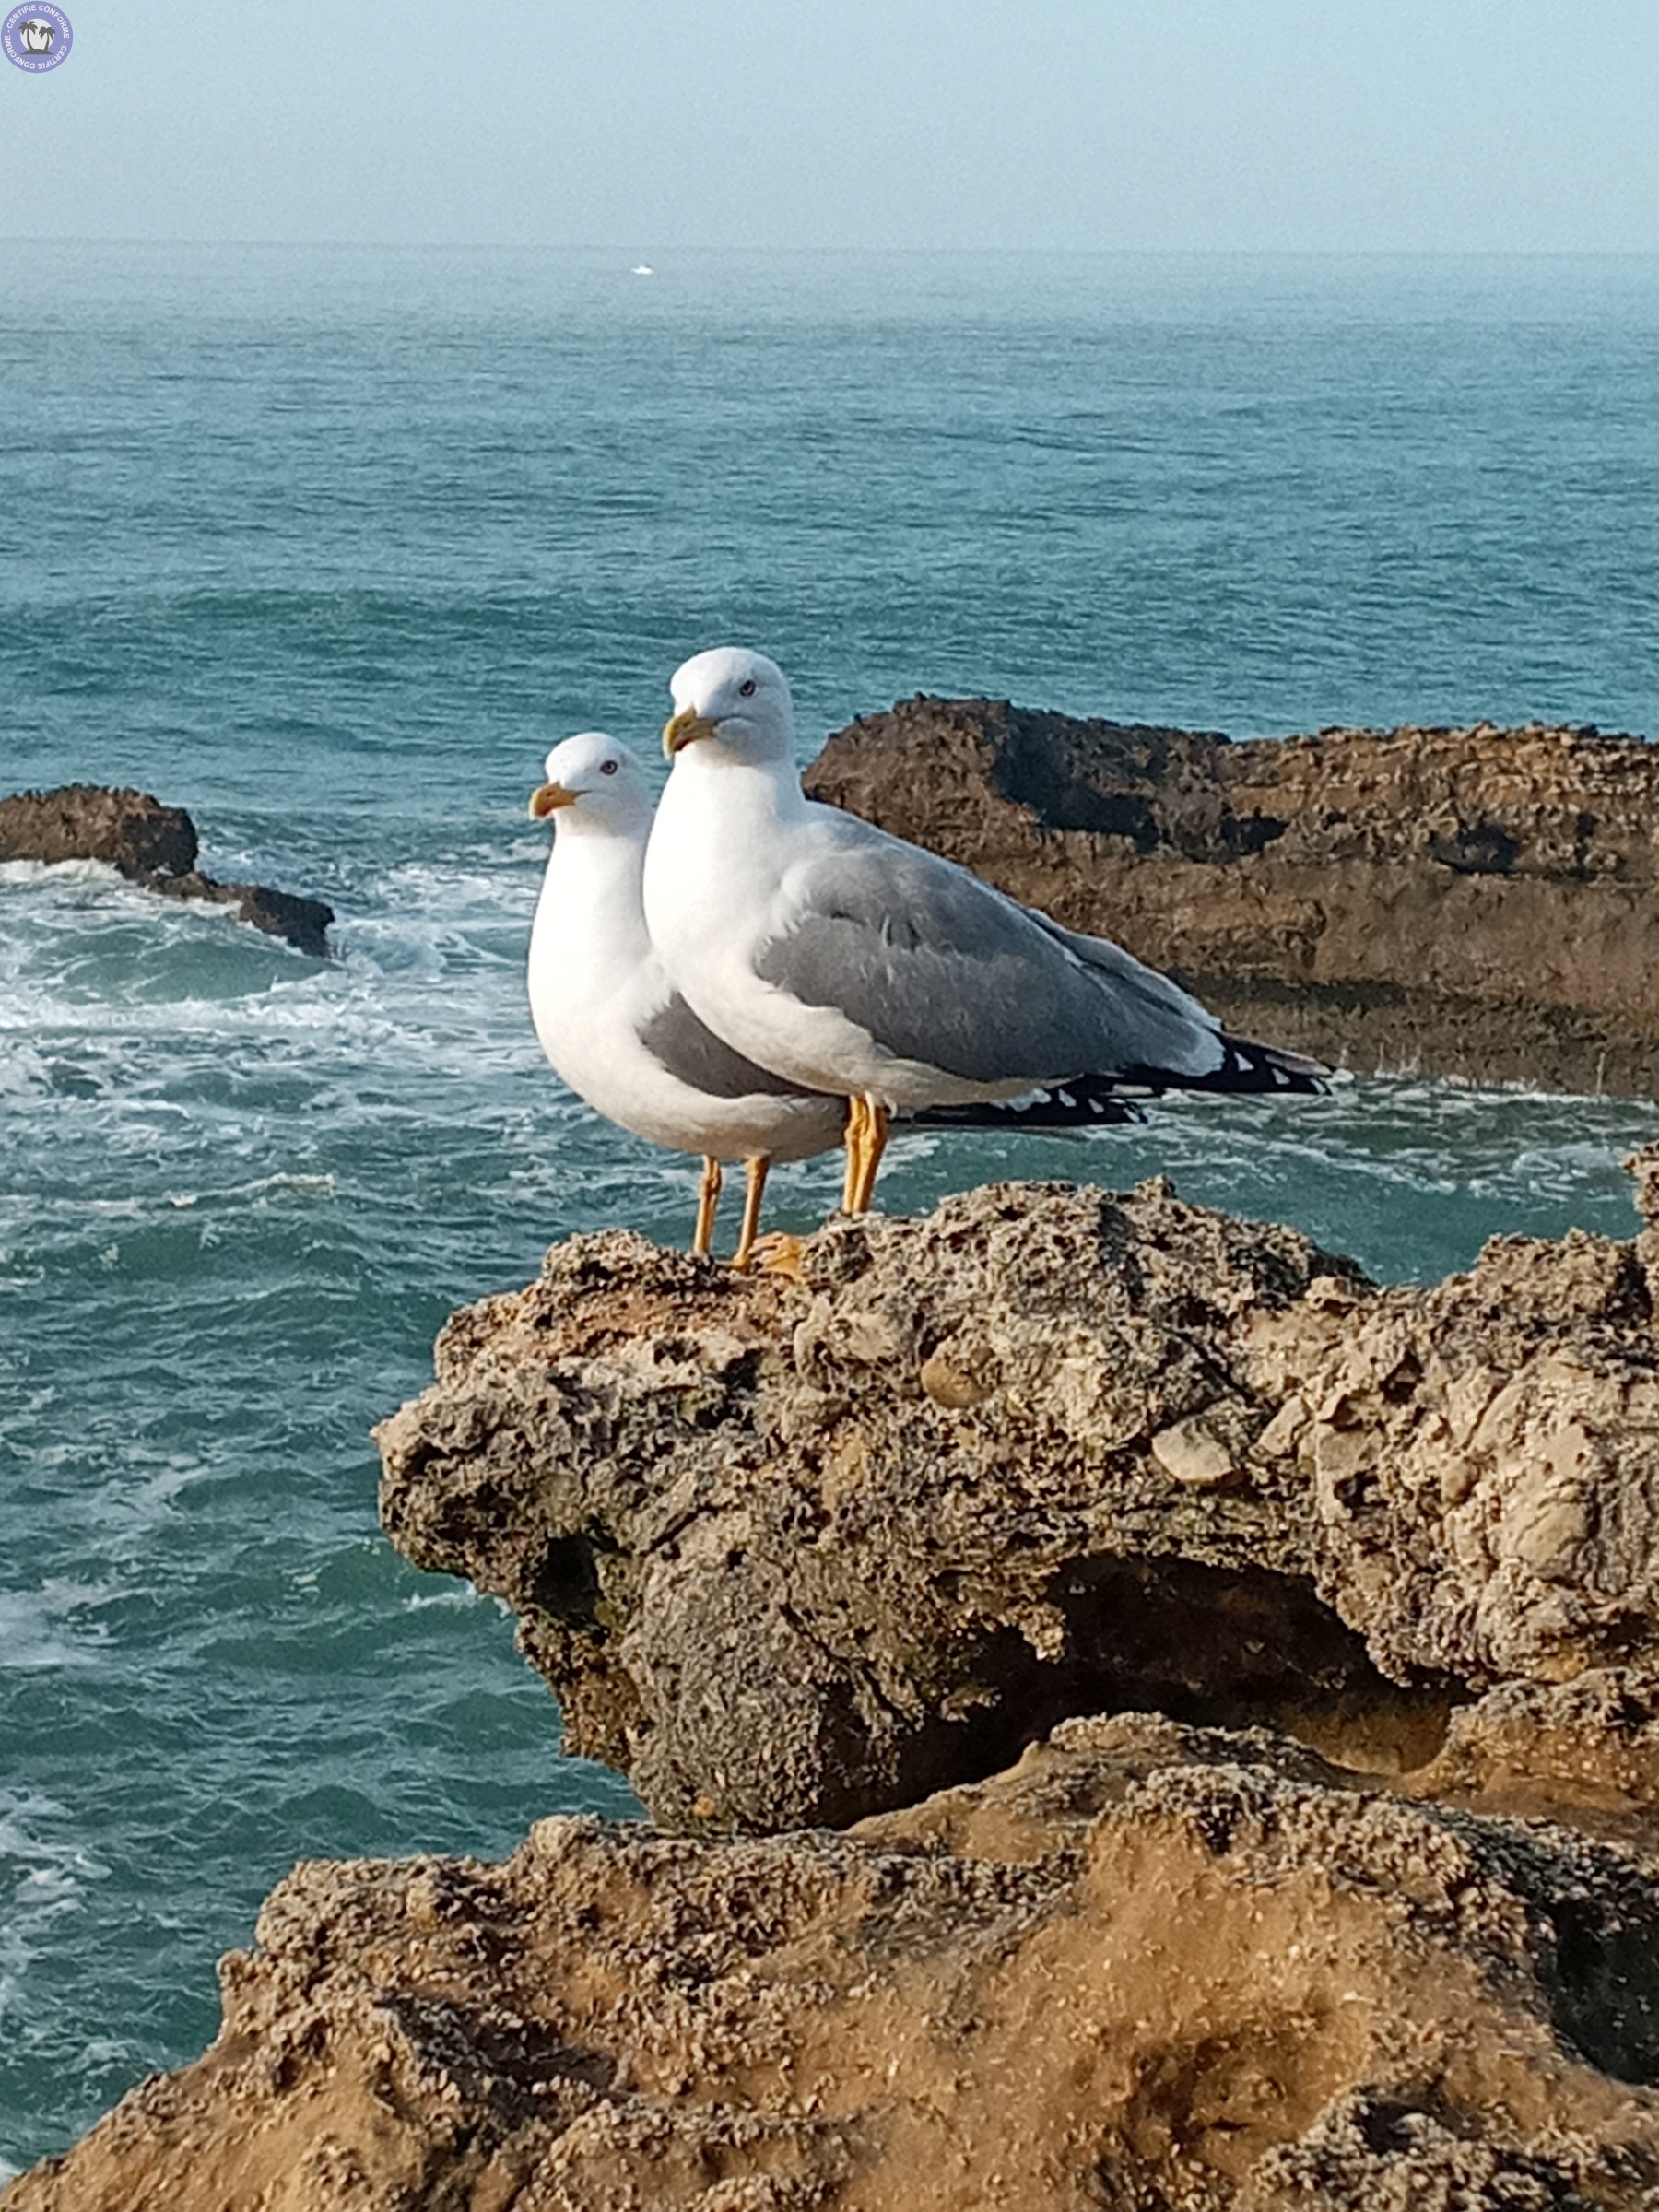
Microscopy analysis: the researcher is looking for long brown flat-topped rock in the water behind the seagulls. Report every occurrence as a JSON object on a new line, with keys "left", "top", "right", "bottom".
{"left": 807, "top": 697, "right": 1659, "bottom": 1097}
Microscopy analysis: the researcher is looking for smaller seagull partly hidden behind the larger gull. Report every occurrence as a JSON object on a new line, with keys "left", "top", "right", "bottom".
{"left": 529, "top": 730, "right": 847, "bottom": 1267}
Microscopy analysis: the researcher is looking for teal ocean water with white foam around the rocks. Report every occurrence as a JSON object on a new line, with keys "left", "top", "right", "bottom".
{"left": 0, "top": 239, "right": 1659, "bottom": 2172}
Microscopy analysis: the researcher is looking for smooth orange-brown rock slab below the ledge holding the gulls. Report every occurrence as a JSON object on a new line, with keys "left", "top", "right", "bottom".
{"left": 5, "top": 1719, "right": 1659, "bottom": 2212}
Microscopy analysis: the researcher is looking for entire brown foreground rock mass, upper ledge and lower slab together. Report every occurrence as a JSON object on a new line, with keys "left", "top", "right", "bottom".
{"left": 16, "top": 1146, "right": 1659, "bottom": 2212}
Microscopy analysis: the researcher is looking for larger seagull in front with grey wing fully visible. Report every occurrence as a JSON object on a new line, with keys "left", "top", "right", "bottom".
{"left": 643, "top": 646, "right": 1327, "bottom": 1215}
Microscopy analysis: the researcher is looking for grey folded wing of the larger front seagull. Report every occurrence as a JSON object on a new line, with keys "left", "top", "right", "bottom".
{"left": 754, "top": 809, "right": 1218, "bottom": 1084}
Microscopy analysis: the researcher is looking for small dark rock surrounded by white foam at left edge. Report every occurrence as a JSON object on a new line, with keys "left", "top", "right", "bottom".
{"left": 0, "top": 783, "right": 334, "bottom": 958}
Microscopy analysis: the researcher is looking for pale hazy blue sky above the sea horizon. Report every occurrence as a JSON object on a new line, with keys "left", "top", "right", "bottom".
{"left": 0, "top": 0, "right": 1659, "bottom": 256}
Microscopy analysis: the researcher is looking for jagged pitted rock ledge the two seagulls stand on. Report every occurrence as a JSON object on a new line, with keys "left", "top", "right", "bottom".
{"left": 378, "top": 1150, "right": 1659, "bottom": 1830}
